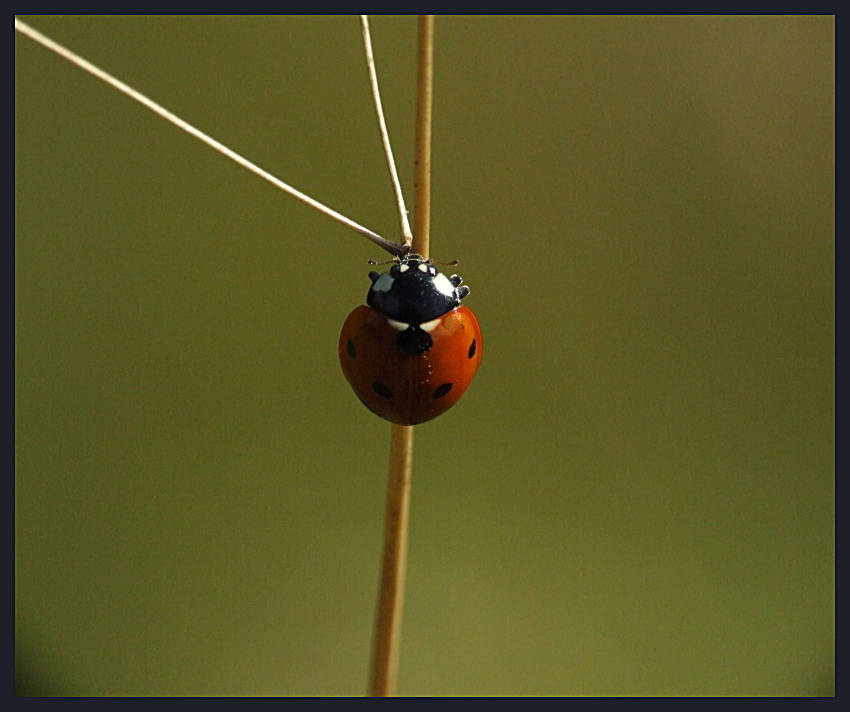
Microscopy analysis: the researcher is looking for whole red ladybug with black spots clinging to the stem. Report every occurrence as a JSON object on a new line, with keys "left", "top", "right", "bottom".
{"left": 339, "top": 253, "right": 482, "bottom": 425}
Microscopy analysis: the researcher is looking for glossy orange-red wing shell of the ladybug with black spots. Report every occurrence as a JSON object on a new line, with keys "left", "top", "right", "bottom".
{"left": 339, "top": 306, "right": 483, "bottom": 425}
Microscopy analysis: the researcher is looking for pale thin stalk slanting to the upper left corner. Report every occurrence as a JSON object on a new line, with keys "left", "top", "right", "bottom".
{"left": 15, "top": 18, "right": 406, "bottom": 257}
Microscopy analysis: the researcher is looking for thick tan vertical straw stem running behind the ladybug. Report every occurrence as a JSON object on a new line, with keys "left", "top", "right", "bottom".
{"left": 369, "top": 15, "right": 434, "bottom": 697}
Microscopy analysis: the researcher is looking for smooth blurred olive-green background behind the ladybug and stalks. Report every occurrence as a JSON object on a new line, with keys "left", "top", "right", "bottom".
{"left": 15, "top": 17, "right": 835, "bottom": 695}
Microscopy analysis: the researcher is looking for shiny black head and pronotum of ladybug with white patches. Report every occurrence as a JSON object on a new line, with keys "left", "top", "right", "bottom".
{"left": 366, "top": 253, "right": 469, "bottom": 325}
